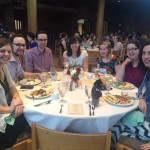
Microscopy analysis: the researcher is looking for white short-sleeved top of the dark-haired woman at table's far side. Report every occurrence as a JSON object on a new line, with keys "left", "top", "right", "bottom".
{"left": 63, "top": 50, "right": 88, "bottom": 66}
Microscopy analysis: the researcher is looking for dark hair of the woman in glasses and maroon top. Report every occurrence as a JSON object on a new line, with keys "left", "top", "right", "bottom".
{"left": 126, "top": 40, "right": 146, "bottom": 70}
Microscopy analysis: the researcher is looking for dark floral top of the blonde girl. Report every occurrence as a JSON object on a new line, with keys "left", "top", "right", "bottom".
{"left": 98, "top": 56, "right": 120, "bottom": 75}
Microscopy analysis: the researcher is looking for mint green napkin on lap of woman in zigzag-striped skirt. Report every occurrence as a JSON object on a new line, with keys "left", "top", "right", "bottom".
{"left": 122, "top": 110, "right": 144, "bottom": 126}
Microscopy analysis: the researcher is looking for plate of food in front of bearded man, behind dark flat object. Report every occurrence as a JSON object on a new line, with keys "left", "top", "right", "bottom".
{"left": 18, "top": 79, "right": 41, "bottom": 85}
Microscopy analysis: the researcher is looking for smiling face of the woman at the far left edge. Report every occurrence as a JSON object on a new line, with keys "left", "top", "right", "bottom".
{"left": 0, "top": 45, "right": 12, "bottom": 64}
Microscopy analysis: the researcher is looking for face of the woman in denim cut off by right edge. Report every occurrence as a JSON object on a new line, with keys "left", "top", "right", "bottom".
{"left": 142, "top": 45, "right": 150, "bottom": 69}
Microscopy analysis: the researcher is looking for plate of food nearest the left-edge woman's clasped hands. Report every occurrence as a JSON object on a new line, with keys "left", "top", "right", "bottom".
{"left": 25, "top": 88, "right": 53, "bottom": 99}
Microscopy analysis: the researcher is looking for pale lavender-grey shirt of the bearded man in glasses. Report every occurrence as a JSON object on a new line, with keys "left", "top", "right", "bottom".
{"left": 8, "top": 55, "right": 24, "bottom": 82}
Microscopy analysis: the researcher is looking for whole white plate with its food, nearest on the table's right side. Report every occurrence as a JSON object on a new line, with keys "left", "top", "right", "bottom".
{"left": 106, "top": 94, "right": 134, "bottom": 106}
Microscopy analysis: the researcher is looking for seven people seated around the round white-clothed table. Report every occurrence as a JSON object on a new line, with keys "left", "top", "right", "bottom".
{"left": 0, "top": 31, "right": 150, "bottom": 150}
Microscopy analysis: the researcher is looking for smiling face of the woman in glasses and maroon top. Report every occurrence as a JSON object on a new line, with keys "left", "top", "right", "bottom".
{"left": 127, "top": 43, "right": 140, "bottom": 61}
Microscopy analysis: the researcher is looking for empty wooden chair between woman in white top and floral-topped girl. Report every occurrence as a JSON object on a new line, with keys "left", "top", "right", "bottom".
{"left": 87, "top": 51, "right": 100, "bottom": 71}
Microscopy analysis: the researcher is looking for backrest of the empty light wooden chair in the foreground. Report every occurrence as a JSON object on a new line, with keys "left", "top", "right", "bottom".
{"left": 32, "top": 123, "right": 111, "bottom": 150}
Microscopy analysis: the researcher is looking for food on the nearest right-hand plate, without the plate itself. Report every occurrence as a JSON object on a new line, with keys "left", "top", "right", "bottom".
{"left": 106, "top": 94, "right": 131, "bottom": 104}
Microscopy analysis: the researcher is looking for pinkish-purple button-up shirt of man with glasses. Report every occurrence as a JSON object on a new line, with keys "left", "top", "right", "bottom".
{"left": 25, "top": 47, "right": 53, "bottom": 73}
